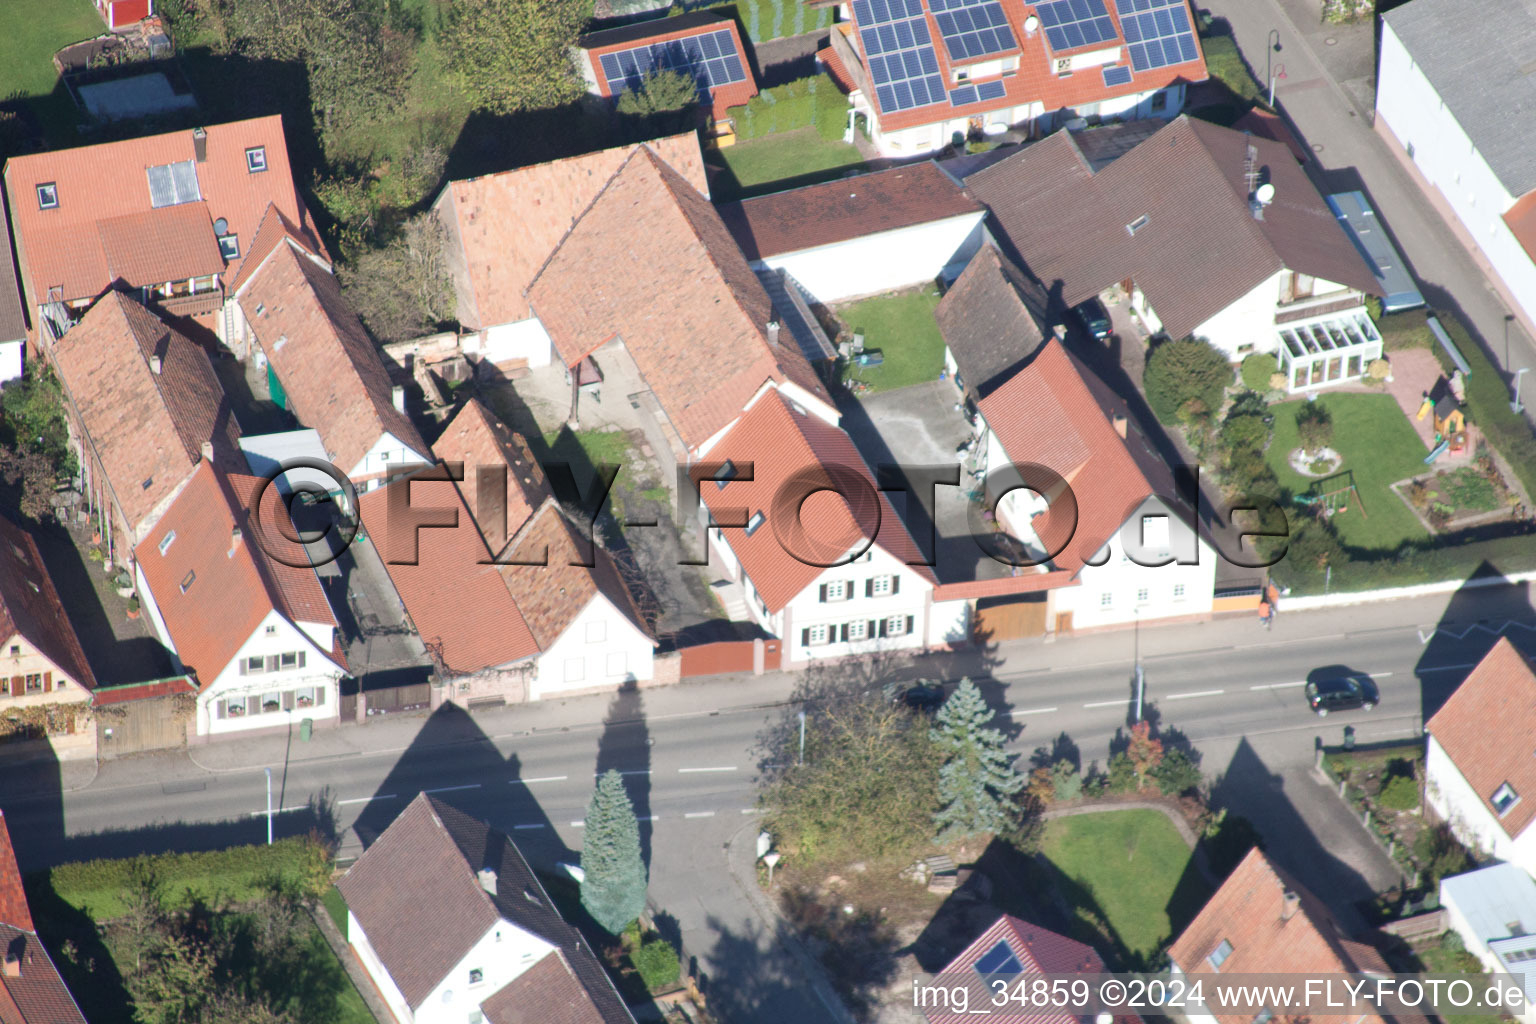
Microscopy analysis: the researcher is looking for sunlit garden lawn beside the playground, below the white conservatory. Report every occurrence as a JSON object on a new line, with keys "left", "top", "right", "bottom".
{"left": 1267, "top": 393, "right": 1428, "bottom": 551}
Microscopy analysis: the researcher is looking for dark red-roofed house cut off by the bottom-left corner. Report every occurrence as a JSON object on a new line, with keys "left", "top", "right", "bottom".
{"left": 0, "top": 815, "right": 86, "bottom": 1024}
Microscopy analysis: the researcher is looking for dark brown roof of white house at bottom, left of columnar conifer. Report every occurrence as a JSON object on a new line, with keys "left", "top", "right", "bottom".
{"left": 336, "top": 794, "right": 633, "bottom": 1024}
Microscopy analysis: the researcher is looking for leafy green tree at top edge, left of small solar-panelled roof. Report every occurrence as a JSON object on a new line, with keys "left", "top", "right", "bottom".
{"left": 442, "top": 0, "right": 593, "bottom": 114}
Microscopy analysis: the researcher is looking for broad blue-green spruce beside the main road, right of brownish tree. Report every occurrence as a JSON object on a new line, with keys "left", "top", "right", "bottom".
{"left": 931, "top": 679, "right": 1026, "bottom": 843}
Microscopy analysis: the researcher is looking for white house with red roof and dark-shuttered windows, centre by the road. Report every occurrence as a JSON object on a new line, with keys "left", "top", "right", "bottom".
{"left": 694, "top": 391, "right": 969, "bottom": 666}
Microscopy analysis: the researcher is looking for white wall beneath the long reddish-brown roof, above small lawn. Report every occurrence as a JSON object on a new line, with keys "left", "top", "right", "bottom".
{"left": 753, "top": 210, "right": 985, "bottom": 302}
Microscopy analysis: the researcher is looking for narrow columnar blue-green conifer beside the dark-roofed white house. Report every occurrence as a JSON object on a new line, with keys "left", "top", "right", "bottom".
{"left": 581, "top": 769, "right": 647, "bottom": 935}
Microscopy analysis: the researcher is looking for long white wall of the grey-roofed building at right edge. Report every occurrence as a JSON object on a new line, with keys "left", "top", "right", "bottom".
{"left": 1376, "top": 21, "right": 1536, "bottom": 333}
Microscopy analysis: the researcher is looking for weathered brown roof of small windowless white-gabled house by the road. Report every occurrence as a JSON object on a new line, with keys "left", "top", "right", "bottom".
{"left": 501, "top": 497, "right": 648, "bottom": 649}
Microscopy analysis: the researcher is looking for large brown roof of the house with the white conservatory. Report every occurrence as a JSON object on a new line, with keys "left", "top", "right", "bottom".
{"left": 966, "top": 117, "right": 1379, "bottom": 338}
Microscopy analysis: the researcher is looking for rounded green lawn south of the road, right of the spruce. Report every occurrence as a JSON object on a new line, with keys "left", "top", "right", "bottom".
{"left": 1040, "top": 811, "right": 1210, "bottom": 970}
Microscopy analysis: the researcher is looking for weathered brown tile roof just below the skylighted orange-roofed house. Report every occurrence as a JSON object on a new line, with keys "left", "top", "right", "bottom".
{"left": 54, "top": 292, "right": 244, "bottom": 530}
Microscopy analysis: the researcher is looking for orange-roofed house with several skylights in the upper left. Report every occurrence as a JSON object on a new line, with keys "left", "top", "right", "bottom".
{"left": 5, "top": 115, "right": 321, "bottom": 347}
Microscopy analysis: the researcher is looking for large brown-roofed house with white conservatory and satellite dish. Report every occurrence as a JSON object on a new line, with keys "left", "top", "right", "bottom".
{"left": 965, "top": 117, "right": 1382, "bottom": 391}
